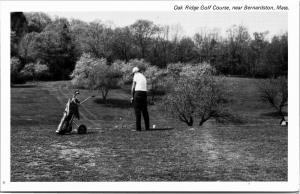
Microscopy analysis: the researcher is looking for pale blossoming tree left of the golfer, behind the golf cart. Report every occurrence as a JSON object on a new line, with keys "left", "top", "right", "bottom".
{"left": 71, "top": 54, "right": 122, "bottom": 103}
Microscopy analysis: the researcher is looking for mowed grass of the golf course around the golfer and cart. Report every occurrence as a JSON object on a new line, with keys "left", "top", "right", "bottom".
{"left": 11, "top": 78, "right": 288, "bottom": 182}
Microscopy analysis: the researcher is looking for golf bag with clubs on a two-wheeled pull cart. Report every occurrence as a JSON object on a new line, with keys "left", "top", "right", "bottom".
{"left": 56, "top": 90, "right": 95, "bottom": 135}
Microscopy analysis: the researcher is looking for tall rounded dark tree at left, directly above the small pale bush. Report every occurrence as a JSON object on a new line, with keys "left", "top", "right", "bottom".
{"left": 33, "top": 18, "right": 77, "bottom": 80}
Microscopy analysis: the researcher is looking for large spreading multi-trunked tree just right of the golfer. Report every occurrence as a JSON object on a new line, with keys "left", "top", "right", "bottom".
{"left": 164, "top": 63, "right": 238, "bottom": 126}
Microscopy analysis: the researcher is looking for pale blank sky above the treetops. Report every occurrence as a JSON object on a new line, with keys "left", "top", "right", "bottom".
{"left": 47, "top": 11, "right": 288, "bottom": 38}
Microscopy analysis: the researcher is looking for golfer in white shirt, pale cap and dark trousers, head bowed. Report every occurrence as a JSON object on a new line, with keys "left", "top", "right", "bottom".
{"left": 131, "top": 67, "right": 149, "bottom": 131}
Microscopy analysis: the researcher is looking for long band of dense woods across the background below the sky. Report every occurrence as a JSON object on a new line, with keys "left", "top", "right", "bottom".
{"left": 11, "top": 12, "right": 288, "bottom": 83}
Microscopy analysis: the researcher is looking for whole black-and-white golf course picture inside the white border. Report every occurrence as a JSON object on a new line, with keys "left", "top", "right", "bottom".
{"left": 1, "top": 2, "right": 299, "bottom": 190}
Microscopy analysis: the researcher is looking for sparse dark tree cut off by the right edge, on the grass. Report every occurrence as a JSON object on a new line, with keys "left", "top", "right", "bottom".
{"left": 258, "top": 77, "right": 288, "bottom": 119}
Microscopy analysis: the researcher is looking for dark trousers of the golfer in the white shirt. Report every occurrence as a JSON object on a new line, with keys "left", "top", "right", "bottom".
{"left": 133, "top": 91, "right": 149, "bottom": 131}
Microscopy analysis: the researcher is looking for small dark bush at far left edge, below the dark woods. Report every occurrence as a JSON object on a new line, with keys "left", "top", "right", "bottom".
{"left": 10, "top": 57, "right": 25, "bottom": 84}
